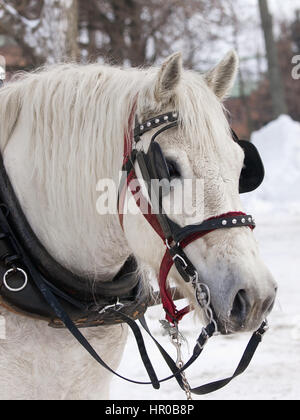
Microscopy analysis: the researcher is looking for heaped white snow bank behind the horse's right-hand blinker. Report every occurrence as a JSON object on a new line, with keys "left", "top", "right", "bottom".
{"left": 242, "top": 115, "right": 300, "bottom": 217}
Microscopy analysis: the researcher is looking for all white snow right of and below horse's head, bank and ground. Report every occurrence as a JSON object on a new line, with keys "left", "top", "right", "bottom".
{"left": 111, "top": 116, "right": 300, "bottom": 401}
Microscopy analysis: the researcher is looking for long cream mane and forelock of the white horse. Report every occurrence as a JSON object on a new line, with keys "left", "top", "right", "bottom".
{"left": 0, "top": 60, "right": 229, "bottom": 278}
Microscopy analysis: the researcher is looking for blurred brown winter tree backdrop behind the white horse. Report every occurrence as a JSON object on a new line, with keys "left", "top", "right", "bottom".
{"left": 0, "top": 0, "right": 300, "bottom": 136}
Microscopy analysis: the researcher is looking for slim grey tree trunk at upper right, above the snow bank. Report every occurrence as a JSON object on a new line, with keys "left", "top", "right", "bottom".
{"left": 258, "top": 0, "right": 288, "bottom": 118}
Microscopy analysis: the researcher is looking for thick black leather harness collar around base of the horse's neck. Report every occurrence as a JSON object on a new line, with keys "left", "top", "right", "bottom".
{"left": 0, "top": 153, "right": 150, "bottom": 327}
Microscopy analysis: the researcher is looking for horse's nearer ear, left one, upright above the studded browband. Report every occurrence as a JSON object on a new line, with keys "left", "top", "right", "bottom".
{"left": 154, "top": 53, "right": 182, "bottom": 102}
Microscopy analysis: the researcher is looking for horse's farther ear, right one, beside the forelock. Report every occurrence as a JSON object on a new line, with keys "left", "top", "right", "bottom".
{"left": 204, "top": 50, "right": 239, "bottom": 100}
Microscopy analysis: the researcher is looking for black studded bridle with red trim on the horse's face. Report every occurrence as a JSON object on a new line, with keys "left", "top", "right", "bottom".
{"left": 118, "top": 107, "right": 255, "bottom": 324}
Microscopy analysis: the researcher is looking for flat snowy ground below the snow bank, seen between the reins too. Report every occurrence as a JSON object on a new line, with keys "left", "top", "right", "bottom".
{"left": 111, "top": 217, "right": 300, "bottom": 400}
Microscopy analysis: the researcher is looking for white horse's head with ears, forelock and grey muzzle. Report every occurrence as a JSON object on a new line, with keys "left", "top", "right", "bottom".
{"left": 124, "top": 52, "right": 276, "bottom": 333}
